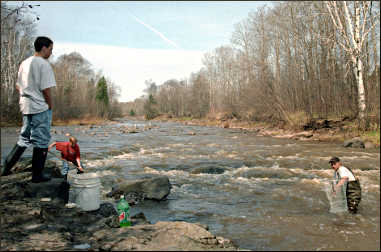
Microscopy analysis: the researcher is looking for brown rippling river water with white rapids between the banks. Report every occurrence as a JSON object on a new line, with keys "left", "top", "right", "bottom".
{"left": 1, "top": 121, "right": 380, "bottom": 251}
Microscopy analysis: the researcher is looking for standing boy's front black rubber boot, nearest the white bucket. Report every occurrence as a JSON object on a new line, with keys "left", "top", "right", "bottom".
{"left": 32, "top": 147, "right": 51, "bottom": 183}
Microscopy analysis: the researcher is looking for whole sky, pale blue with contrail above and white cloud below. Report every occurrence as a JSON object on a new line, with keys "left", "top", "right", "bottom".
{"left": 17, "top": 1, "right": 271, "bottom": 101}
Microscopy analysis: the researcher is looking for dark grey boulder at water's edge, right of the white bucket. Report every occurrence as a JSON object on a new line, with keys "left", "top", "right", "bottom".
{"left": 107, "top": 176, "right": 172, "bottom": 201}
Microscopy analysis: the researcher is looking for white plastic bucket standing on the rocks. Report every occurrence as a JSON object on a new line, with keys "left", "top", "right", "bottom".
{"left": 68, "top": 173, "right": 101, "bottom": 211}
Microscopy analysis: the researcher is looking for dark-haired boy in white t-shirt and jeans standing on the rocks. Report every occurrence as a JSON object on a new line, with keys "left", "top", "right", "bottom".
{"left": 1, "top": 37, "right": 56, "bottom": 183}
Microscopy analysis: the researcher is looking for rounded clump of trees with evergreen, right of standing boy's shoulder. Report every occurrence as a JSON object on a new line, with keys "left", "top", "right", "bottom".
{"left": 52, "top": 52, "right": 120, "bottom": 120}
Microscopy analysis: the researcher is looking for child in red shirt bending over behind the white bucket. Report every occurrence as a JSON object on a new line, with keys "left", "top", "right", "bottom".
{"left": 48, "top": 136, "right": 84, "bottom": 181}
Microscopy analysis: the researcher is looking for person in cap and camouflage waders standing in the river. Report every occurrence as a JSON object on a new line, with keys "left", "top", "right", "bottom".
{"left": 329, "top": 157, "right": 361, "bottom": 214}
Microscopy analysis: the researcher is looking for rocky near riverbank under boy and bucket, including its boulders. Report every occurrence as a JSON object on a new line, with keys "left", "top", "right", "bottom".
{"left": 0, "top": 159, "right": 238, "bottom": 251}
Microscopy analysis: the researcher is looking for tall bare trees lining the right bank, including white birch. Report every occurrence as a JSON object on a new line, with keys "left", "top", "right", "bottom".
{"left": 125, "top": 1, "right": 380, "bottom": 129}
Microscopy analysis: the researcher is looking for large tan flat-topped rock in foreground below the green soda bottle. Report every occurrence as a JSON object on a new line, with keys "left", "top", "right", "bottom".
{"left": 90, "top": 221, "right": 237, "bottom": 251}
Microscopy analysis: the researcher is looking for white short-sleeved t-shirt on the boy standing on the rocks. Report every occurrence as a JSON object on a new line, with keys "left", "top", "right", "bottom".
{"left": 16, "top": 56, "right": 56, "bottom": 114}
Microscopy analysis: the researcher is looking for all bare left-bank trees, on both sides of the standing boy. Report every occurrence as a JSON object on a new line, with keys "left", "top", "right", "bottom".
{"left": 0, "top": 1, "right": 120, "bottom": 122}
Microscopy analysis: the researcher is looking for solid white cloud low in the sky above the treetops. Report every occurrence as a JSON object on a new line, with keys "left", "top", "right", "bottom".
{"left": 53, "top": 41, "right": 205, "bottom": 102}
